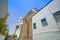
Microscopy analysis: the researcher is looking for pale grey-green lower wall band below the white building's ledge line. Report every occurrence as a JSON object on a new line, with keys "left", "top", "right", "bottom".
{"left": 33, "top": 31, "right": 60, "bottom": 40}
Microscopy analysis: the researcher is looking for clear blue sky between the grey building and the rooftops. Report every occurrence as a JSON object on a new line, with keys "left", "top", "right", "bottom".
{"left": 8, "top": 0, "right": 50, "bottom": 35}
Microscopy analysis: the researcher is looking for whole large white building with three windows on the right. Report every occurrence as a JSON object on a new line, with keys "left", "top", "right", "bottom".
{"left": 32, "top": 0, "right": 60, "bottom": 40}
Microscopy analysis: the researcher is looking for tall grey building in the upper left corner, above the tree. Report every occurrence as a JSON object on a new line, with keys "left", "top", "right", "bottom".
{"left": 0, "top": 0, "right": 8, "bottom": 18}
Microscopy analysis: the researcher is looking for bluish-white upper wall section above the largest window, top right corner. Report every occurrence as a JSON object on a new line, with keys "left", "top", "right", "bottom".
{"left": 47, "top": 0, "right": 60, "bottom": 13}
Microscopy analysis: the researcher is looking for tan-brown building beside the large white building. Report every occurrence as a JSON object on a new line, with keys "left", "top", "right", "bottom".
{"left": 20, "top": 9, "right": 37, "bottom": 40}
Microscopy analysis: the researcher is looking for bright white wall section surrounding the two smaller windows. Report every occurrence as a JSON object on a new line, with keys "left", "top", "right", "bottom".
{"left": 32, "top": 6, "right": 58, "bottom": 33}
